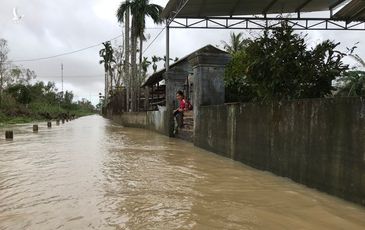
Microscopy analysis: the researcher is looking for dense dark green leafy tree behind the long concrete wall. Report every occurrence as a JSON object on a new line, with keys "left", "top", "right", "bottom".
{"left": 224, "top": 23, "right": 365, "bottom": 102}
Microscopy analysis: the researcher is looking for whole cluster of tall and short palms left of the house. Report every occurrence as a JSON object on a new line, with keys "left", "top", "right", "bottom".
{"left": 99, "top": 0, "right": 166, "bottom": 111}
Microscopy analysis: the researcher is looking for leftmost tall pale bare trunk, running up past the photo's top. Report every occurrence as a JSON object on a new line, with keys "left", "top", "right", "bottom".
{"left": 124, "top": 0, "right": 131, "bottom": 112}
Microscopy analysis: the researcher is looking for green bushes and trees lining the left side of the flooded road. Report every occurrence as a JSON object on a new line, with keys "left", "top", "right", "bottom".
{"left": 0, "top": 39, "right": 95, "bottom": 125}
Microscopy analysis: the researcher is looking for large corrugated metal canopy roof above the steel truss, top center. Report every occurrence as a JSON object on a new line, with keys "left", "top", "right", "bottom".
{"left": 162, "top": 0, "right": 343, "bottom": 18}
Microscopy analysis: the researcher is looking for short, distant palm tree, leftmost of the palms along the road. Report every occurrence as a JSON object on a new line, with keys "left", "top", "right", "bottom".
{"left": 99, "top": 41, "right": 115, "bottom": 101}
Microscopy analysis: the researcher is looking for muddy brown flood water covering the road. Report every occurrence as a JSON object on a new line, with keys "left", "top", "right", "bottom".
{"left": 0, "top": 116, "right": 365, "bottom": 230}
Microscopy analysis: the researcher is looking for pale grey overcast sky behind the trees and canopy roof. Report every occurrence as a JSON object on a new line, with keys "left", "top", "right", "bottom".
{"left": 0, "top": 0, "right": 365, "bottom": 104}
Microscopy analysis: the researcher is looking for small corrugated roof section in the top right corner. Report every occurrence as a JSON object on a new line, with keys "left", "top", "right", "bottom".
{"left": 333, "top": 0, "right": 365, "bottom": 21}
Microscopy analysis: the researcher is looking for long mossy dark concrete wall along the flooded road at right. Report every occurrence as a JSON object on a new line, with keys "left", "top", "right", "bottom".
{"left": 194, "top": 98, "right": 365, "bottom": 205}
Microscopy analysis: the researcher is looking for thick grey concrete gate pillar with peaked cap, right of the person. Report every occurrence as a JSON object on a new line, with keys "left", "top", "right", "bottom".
{"left": 189, "top": 46, "right": 231, "bottom": 143}
